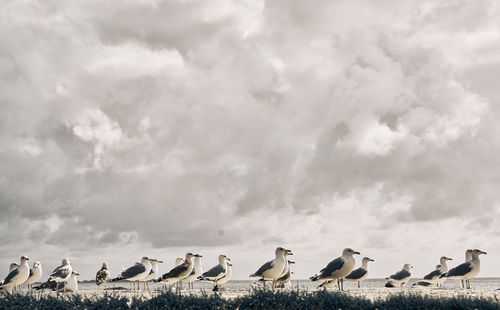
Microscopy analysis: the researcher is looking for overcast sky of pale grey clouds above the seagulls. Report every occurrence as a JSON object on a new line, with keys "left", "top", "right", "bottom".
{"left": 0, "top": 0, "right": 500, "bottom": 279}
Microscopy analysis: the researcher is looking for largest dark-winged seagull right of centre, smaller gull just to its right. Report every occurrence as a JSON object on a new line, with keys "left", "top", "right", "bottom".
{"left": 309, "top": 248, "right": 360, "bottom": 290}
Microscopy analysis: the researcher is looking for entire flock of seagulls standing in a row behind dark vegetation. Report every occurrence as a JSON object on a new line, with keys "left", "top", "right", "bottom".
{"left": 0, "top": 247, "right": 486, "bottom": 293}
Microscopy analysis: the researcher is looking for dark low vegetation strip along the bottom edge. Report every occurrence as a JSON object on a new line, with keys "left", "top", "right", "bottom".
{"left": 0, "top": 290, "right": 500, "bottom": 310}
